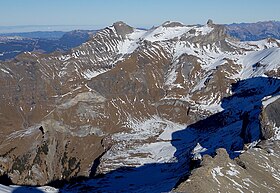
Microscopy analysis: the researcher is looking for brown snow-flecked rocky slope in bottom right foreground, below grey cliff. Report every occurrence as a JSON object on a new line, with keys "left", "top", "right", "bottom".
{"left": 173, "top": 141, "right": 280, "bottom": 193}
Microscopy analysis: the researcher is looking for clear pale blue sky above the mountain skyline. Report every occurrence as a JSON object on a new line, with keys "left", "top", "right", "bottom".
{"left": 0, "top": 0, "right": 280, "bottom": 27}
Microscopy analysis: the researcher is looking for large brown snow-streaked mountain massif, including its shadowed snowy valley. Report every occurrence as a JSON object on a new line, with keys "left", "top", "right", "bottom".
{"left": 0, "top": 21, "right": 280, "bottom": 192}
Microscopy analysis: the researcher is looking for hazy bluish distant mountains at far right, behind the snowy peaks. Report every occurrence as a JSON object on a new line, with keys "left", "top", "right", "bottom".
{"left": 227, "top": 21, "right": 280, "bottom": 41}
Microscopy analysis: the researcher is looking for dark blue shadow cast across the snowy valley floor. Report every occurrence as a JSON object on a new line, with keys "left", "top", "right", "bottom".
{"left": 0, "top": 77, "right": 280, "bottom": 192}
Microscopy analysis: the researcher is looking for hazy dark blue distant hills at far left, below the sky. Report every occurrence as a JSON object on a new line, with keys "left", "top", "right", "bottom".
{"left": 0, "top": 30, "right": 96, "bottom": 60}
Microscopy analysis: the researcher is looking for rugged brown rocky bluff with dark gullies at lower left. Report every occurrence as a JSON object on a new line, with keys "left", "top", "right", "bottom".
{"left": 0, "top": 117, "right": 105, "bottom": 185}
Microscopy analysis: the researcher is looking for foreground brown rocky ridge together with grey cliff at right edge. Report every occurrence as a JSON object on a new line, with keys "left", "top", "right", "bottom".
{"left": 176, "top": 90, "right": 280, "bottom": 193}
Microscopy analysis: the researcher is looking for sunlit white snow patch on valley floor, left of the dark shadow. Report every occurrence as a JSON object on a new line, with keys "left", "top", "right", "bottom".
{"left": 99, "top": 116, "right": 186, "bottom": 172}
